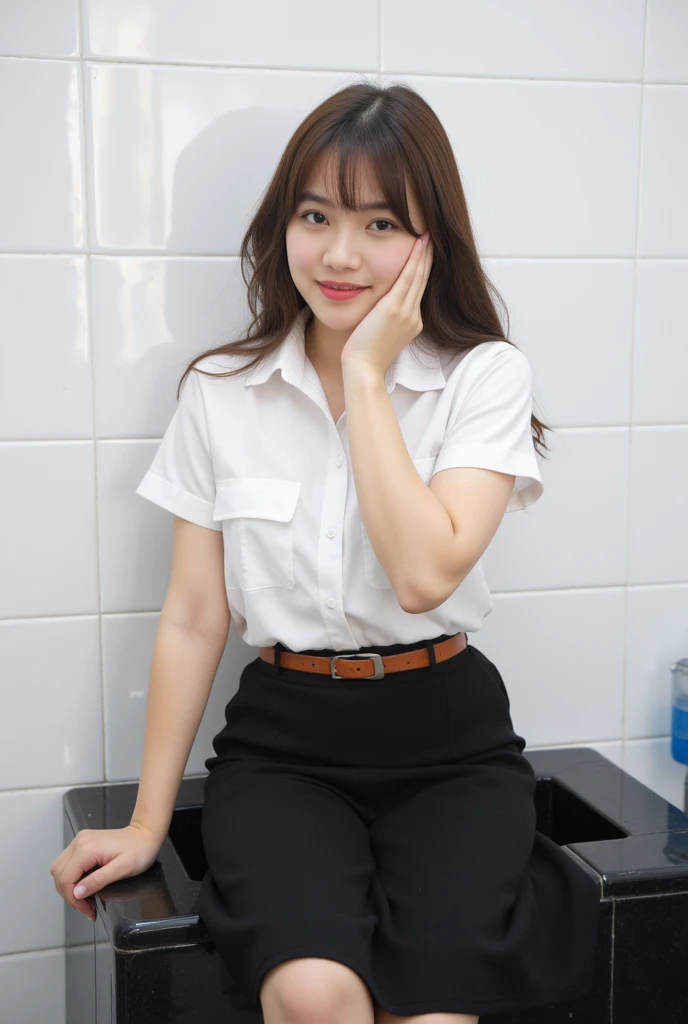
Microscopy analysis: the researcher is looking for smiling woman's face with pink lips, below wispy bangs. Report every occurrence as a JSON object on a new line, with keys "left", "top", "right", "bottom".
{"left": 287, "top": 153, "right": 426, "bottom": 331}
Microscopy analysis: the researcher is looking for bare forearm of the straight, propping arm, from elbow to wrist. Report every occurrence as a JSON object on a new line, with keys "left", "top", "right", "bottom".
{"left": 131, "top": 615, "right": 226, "bottom": 842}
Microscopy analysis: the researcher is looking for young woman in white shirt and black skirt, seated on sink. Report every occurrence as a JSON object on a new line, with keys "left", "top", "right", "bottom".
{"left": 51, "top": 81, "right": 599, "bottom": 1024}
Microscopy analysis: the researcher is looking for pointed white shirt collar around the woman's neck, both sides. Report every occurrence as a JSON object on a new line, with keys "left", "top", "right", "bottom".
{"left": 244, "top": 306, "right": 445, "bottom": 393}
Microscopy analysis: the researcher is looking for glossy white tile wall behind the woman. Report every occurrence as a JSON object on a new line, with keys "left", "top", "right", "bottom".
{"left": 0, "top": 0, "right": 688, "bottom": 1024}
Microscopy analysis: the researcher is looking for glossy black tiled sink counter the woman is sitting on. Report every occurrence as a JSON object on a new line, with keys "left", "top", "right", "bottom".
{"left": 65, "top": 746, "right": 688, "bottom": 1024}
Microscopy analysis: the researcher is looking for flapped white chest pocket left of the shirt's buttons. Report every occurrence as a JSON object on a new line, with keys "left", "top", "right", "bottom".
{"left": 213, "top": 476, "right": 301, "bottom": 591}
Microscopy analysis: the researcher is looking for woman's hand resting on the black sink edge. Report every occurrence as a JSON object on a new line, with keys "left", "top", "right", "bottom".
{"left": 50, "top": 823, "right": 165, "bottom": 921}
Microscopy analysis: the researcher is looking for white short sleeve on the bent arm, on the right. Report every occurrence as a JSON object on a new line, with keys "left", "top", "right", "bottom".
{"left": 434, "top": 343, "right": 545, "bottom": 512}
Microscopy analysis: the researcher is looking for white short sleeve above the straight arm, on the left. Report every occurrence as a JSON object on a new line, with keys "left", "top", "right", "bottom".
{"left": 136, "top": 370, "right": 222, "bottom": 530}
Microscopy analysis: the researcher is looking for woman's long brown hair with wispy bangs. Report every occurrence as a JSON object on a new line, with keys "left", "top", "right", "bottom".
{"left": 177, "top": 80, "right": 552, "bottom": 455}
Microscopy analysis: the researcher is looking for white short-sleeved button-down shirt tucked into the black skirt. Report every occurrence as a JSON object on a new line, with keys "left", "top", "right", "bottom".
{"left": 136, "top": 306, "right": 543, "bottom": 651}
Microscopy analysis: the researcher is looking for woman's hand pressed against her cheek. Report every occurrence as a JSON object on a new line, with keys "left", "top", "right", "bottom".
{"left": 342, "top": 231, "right": 432, "bottom": 375}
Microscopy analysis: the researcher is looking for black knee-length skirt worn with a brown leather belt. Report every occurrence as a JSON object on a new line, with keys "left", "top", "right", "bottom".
{"left": 199, "top": 634, "right": 600, "bottom": 1016}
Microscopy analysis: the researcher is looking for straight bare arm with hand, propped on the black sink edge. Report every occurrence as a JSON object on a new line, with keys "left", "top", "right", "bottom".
{"left": 50, "top": 516, "right": 230, "bottom": 921}
